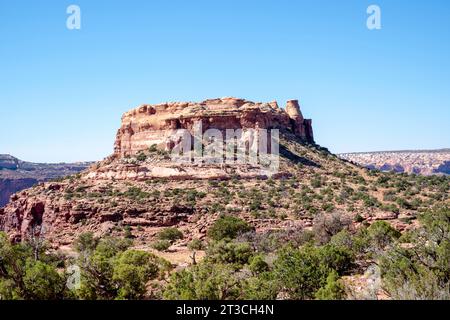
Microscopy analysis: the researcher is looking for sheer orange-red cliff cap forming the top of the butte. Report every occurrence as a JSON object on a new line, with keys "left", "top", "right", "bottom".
{"left": 114, "top": 98, "right": 314, "bottom": 157}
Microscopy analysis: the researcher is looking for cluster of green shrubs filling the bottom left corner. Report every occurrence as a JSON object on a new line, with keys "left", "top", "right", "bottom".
{"left": 0, "top": 233, "right": 171, "bottom": 300}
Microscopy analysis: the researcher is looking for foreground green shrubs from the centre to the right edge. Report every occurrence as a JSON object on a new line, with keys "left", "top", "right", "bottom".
{"left": 160, "top": 207, "right": 450, "bottom": 300}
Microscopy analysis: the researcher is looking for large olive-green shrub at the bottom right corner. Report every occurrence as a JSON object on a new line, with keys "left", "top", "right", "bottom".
{"left": 380, "top": 207, "right": 450, "bottom": 299}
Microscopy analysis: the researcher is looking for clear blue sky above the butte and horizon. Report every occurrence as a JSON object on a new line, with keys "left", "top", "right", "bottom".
{"left": 0, "top": 0, "right": 450, "bottom": 162}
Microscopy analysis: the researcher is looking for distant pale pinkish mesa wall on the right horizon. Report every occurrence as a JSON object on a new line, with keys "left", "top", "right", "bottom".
{"left": 338, "top": 149, "right": 450, "bottom": 175}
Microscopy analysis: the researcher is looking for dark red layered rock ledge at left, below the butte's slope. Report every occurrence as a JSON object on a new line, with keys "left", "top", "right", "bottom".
{"left": 0, "top": 180, "right": 201, "bottom": 246}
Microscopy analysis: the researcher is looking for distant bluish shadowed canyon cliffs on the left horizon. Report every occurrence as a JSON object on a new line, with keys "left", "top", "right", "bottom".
{"left": 0, "top": 154, "right": 91, "bottom": 207}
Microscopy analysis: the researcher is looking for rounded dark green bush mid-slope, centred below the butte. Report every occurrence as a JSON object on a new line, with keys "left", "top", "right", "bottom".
{"left": 208, "top": 215, "right": 253, "bottom": 241}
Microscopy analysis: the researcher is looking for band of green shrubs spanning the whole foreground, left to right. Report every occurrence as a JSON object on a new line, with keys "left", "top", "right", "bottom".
{"left": 0, "top": 206, "right": 450, "bottom": 299}
